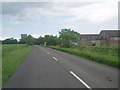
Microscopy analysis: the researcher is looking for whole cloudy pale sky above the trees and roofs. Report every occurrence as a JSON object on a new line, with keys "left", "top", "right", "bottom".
{"left": 0, "top": 0, "right": 119, "bottom": 40}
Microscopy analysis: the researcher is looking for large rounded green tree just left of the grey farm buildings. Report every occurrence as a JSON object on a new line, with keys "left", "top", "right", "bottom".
{"left": 59, "top": 28, "right": 79, "bottom": 47}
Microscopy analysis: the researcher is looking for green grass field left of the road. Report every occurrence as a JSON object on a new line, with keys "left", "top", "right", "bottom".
{"left": 2, "top": 44, "right": 32, "bottom": 84}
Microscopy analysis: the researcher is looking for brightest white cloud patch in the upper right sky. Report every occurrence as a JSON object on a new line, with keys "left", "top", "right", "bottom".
{"left": 64, "top": 1, "right": 118, "bottom": 24}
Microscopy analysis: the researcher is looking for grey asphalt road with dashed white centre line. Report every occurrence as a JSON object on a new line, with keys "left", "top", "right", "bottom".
{"left": 3, "top": 45, "right": 118, "bottom": 90}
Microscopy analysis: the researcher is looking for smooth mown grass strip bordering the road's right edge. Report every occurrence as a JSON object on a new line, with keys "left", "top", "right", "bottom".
{"left": 50, "top": 46, "right": 120, "bottom": 68}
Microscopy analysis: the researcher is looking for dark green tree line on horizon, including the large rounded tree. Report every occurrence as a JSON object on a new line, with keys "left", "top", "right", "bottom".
{"left": 2, "top": 28, "right": 80, "bottom": 47}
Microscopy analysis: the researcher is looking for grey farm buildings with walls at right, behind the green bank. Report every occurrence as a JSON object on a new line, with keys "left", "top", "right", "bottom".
{"left": 80, "top": 30, "right": 120, "bottom": 46}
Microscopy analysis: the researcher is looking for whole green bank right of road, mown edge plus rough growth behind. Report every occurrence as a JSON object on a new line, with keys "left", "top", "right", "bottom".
{"left": 51, "top": 46, "right": 120, "bottom": 68}
